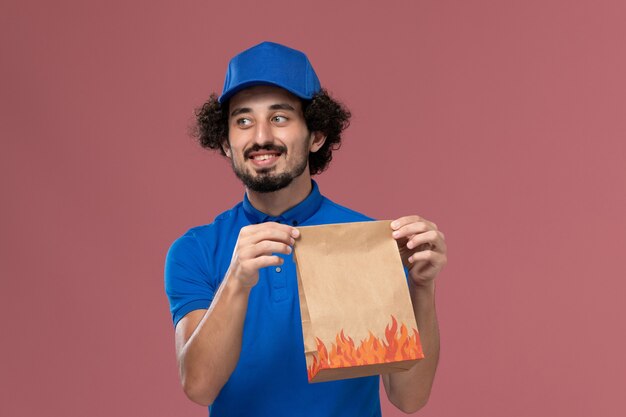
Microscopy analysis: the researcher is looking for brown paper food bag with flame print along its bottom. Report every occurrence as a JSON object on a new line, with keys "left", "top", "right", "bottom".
{"left": 294, "top": 221, "right": 424, "bottom": 382}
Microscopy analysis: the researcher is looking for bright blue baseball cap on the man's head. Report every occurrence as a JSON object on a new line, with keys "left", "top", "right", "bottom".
{"left": 218, "top": 42, "right": 321, "bottom": 103}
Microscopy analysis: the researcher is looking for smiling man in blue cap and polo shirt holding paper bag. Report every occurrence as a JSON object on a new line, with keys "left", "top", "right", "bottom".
{"left": 165, "top": 42, "right": 447, "bottom": 417}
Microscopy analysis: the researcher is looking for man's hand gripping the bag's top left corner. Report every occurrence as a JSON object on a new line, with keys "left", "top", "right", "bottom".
{"left": 227, "top": 222, "right": 300, "bottom": 288}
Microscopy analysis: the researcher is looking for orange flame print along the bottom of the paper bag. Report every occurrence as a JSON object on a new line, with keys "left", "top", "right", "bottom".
{"left": 307, "top": 316, "right": 423, "bottom": 381}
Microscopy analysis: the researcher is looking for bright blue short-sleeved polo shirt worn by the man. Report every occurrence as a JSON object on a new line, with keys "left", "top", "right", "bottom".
{"left": 165, "top": 181, "right": 381, "bottom": 417}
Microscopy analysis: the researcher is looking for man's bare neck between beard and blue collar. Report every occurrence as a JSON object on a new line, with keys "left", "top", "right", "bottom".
{"left": 246, "top": 169, "right": 312, "bottom": 217}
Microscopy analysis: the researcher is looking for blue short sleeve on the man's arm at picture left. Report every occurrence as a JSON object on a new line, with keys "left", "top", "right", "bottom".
{"left": 165, "top": 232, "right": 216, "bottom": 327}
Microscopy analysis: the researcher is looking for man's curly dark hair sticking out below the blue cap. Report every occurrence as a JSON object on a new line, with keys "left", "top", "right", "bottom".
{"left": 191, "top": 89, "right": 351, "bottom": 175}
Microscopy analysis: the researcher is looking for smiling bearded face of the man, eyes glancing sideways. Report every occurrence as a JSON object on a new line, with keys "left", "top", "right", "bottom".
{"left": 224, "top": 86, "right": 323, "bottom": 192}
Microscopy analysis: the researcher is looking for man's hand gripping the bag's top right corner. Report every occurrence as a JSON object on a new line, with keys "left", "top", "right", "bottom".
{"left": 391, "top": 216, "right": 448, "bottom": 286}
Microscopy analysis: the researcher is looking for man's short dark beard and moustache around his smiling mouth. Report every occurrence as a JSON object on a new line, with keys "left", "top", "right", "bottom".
{"left": 231, "top": 146, "right": 309, "bottom": 193}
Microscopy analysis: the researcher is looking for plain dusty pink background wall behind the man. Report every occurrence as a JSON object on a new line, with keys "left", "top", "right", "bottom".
{"left": 0, "top": 0, "right": 626, "bottom": 417}
